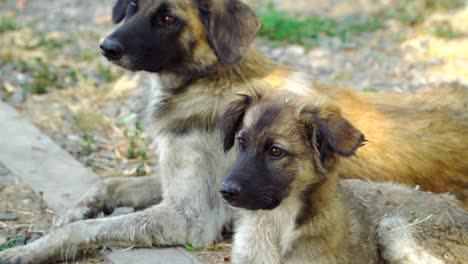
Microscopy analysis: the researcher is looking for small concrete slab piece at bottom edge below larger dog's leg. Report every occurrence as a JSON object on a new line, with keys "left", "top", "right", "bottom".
{"left": 107, "top": 248, "right": 201, "bottom": 264}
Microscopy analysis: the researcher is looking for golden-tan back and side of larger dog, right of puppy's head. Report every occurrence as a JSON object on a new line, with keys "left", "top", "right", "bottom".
{"left": 318, "top": 84, "right": 468, "bottom": 205}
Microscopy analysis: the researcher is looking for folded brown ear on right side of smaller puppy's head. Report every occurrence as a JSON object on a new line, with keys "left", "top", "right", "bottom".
{"left": 301, "top": 105, "right": 366, "bottom": 164}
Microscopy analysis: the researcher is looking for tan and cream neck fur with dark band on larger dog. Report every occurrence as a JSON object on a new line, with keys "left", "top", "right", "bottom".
{"left": 147, "top": 46, "right": 288, "bottom": 134}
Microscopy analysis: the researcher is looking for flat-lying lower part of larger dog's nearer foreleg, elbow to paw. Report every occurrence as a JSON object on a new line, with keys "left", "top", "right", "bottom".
{"left": 0, "top": 195, "right": 229, "bottom": 264}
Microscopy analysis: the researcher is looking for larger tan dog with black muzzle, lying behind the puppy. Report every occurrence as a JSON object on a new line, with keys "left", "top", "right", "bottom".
{"left": 0, "top": 0, "right": 468, "bottom": 263}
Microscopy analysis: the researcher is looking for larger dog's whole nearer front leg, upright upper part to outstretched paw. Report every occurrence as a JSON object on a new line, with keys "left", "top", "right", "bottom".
{"left": 0, "top": 133, "right": 233, "bottom": 263}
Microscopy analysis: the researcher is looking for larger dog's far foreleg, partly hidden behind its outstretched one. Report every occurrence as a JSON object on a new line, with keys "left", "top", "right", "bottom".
{"left": 58, "top": 176, "right": 161, "bottom": 226}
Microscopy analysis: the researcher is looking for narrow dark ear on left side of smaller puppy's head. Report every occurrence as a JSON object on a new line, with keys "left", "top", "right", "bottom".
{"left": 219, "top": 94, "right": 252, "bottom": 152}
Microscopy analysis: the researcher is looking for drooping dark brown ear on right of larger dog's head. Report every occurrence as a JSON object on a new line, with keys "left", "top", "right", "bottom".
{"left": 199, "top": 0, "right": 261, "bottom": 65}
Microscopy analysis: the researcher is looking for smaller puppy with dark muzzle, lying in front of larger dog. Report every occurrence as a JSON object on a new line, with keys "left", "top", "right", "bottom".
{"left": 220, "top": 93, "right": 468, "bottom": 264}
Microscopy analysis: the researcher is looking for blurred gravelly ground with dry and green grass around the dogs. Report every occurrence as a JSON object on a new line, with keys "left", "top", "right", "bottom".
{"left": 0, "top": 0, "right": 468, "bottom": 263}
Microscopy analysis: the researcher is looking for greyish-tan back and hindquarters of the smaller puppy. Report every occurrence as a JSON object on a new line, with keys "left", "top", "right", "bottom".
{"left": 340, "top": 180, "right": 468, "bottom": 263}
